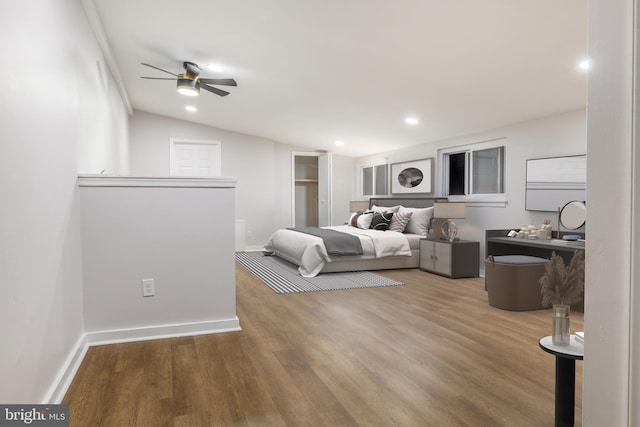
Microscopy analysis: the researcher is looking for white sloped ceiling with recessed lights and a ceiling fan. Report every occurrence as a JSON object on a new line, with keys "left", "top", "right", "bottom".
{"left": 95, "top": 0, "right": 586, "bottom": 156}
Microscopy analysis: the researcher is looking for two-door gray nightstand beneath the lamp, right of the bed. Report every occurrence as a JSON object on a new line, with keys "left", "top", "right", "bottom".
{"left": 420, "top": 239, "right": 480, "bottom": 279}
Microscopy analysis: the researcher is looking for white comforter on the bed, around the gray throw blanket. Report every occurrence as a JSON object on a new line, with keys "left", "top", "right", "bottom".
{"left": 265, "top": 225, "right": 411, "bottom": 277}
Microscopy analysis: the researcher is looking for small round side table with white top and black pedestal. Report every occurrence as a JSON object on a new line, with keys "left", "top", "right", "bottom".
{"left": 540, "top": 335, "right": 584, "bottom": 427}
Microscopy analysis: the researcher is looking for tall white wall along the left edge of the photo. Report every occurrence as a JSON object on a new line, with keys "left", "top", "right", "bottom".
{"left": 0, "top": 0, "right": 128, "bottom": 403}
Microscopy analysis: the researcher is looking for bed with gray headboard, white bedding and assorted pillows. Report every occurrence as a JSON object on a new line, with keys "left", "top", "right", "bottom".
{"left": 264, "top": 197, "right": 438, "bottom": 277}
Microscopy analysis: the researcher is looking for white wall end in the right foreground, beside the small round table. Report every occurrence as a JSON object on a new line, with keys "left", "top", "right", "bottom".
{"left": 582, "top": 0, "right": 640, "bottom": 427}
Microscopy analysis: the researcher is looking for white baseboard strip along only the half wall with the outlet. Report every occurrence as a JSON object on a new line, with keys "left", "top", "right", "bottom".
{"left": 87, "top": 316, "right": 242, "bottom": 346}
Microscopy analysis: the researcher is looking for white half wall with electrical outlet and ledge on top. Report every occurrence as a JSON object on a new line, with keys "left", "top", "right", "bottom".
{"left": 80, "top": 175, "right": 238, "bottom": 342}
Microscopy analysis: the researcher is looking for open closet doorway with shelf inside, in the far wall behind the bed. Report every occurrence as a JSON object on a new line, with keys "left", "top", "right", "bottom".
{"left": 291, "top": 152, "right": 332, "bottom": 227}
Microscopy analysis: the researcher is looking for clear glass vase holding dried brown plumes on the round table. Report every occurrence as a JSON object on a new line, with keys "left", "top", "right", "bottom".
{"left": 539, "top": 251, "right": 584, "bottom": 345}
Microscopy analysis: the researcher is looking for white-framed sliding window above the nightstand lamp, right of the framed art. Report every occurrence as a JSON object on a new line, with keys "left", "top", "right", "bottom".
{"left": 441, "top": 144, "right": 504, "bottom": 196}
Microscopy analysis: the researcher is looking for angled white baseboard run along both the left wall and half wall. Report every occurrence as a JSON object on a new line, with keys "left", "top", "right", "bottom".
{"left": 42, "top": 316, "right": 242, "bottom": 404}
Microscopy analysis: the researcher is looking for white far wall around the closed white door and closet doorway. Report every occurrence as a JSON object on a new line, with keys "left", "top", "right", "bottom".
{"left": 129, "top": 111, "right": 353, "bottom": 249}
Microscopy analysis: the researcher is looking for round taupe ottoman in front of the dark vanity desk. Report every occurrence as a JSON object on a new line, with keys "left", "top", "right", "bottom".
{"left": 484, "top": 255, "right": 548, "bottom": 311}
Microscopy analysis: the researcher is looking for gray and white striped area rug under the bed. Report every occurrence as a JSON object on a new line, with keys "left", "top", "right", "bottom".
{"left": 236, "top": 252, "right": 404, "bottom": 294}
